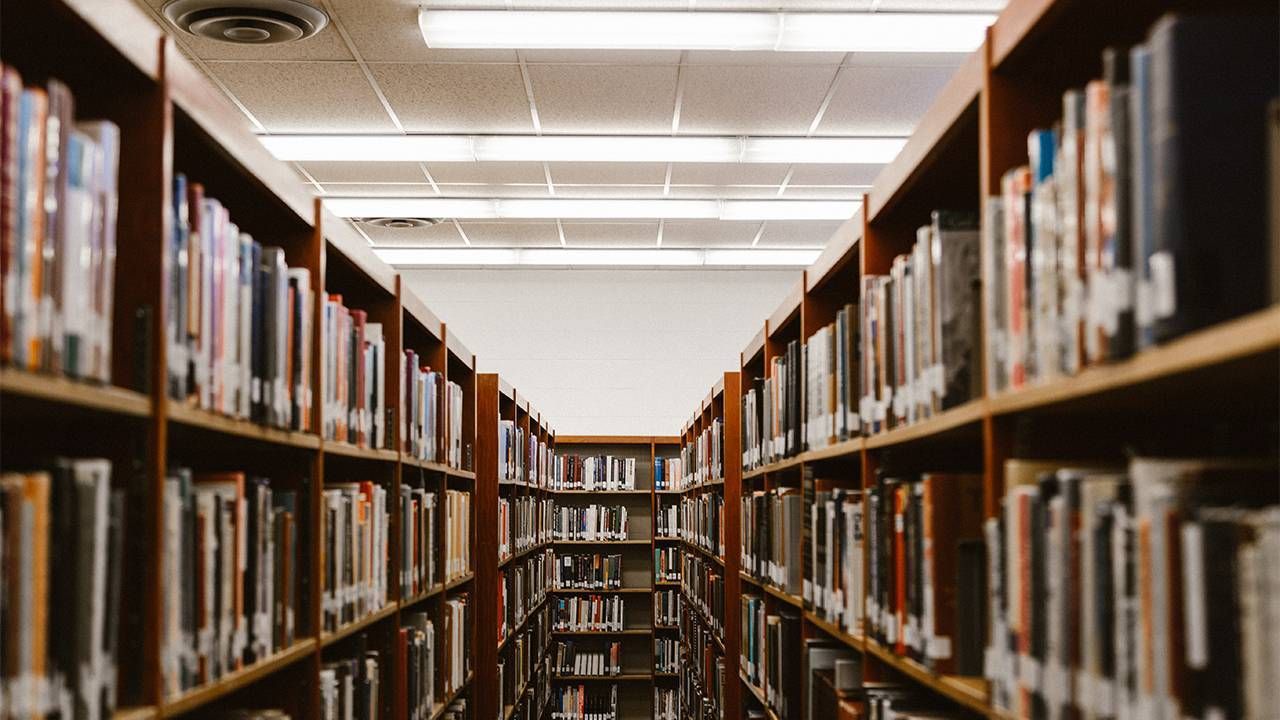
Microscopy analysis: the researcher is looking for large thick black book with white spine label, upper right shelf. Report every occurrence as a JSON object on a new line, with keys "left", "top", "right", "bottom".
{"left": 1140, "top": 14, "right": 1280, "bottom": 342}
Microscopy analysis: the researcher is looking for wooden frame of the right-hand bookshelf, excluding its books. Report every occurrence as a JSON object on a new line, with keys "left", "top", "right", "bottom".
{"left": 727, "top": 0, "right": 1280, "bottom": 719}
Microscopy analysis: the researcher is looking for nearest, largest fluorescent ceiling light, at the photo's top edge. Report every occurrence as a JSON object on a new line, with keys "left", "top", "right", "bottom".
{"left": 417, "top": 9, "right": 996, "bottom": 53}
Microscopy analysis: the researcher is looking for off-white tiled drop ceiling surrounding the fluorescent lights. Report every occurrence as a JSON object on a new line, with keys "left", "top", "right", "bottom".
{"left": 137, "top": 0, "right": 1005, "bottom": 257}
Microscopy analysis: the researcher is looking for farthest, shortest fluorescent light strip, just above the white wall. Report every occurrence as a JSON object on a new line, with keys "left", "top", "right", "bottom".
{"left": 374, "top": 247, "right": 822, "bottom": 268}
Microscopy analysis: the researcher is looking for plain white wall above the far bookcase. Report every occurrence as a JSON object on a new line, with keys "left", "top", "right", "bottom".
{"left": 403, "top": 269, "right": 800, "bottom": 434}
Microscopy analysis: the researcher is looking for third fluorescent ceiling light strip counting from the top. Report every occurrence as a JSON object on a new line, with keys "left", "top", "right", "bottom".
{"left": 324, "top": 197, "right": 860, "bottom": 220}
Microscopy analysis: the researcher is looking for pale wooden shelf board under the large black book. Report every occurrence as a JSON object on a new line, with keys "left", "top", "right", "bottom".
{"left": 987, "top": 305, "right": 1280, "bottom": 415}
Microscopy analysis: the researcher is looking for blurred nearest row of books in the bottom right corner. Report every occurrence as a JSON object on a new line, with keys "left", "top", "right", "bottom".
{"left": 983, "top": 457, "right": 1280, "bottom": 720}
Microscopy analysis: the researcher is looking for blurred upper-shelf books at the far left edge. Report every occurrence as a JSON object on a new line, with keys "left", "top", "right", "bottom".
{"left": 0, "top": 65, "right": 120, "bottom": 383}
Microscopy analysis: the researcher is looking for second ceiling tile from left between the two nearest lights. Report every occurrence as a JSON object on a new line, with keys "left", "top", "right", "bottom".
{"left": 370, "top": 63, "right": 534, "bottom": 133}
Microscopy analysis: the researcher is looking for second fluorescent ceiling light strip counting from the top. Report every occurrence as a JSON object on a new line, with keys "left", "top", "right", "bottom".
{"left": 259, "top": 135, "right": 906, "bottom": 165}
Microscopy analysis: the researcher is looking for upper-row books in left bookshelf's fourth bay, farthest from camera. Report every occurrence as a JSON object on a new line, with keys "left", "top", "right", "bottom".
{"left": 401, "top": 350, "right": 463, "bottom": 468}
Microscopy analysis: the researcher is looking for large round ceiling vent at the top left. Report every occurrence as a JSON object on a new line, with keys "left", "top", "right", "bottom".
{"left": 164, "top": 0, "right": 329, "bottom": 45}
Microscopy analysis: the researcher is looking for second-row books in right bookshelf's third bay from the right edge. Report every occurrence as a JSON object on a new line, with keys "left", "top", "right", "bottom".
{"left": 804, "top": 479, "right": 865, "bottom": 635}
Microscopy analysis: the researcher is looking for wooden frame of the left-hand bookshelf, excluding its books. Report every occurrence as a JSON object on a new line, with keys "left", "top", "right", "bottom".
{"left": 0, "top": 0, "right": 490, "bottom": 719}
